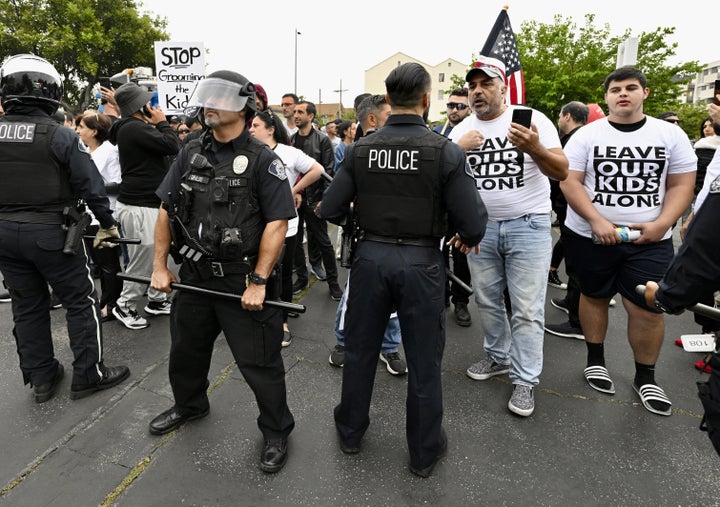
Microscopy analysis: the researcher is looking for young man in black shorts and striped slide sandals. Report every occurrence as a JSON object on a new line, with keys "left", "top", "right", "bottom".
{"left": 560, "top": 67, "right": 697, "bottom": 415}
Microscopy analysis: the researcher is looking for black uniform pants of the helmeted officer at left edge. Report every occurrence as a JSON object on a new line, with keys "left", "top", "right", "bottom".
{"left": 0, "top": 221, "right": 103, "bottom": 385}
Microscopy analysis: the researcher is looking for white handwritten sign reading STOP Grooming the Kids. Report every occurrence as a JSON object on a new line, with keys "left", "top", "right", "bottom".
{"left": 155, "top": 41, "right": 205, "bottom": 115}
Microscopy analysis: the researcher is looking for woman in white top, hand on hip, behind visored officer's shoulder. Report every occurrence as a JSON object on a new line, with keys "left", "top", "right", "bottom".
{"left": 250, "top": 109, "right": 325, "bottom": 347}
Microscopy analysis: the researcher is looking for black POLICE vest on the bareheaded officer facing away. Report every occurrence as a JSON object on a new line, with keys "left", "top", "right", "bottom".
{"left": 352, "top": 131, "right": 448, "bottom": 239}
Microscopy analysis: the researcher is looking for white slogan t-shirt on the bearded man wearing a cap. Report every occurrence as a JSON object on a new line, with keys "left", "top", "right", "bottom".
{"left": 450, "top": 106, "right": 561, "bottom": 221}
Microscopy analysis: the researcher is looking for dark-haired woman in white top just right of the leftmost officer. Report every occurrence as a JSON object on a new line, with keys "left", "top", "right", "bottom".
{"left": 77, "top": 111, "right": 122, "bottom": 321}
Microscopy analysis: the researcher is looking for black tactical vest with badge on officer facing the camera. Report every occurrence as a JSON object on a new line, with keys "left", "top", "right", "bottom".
{"left": 178, "top": 136, "right": 265, "bottom": 262}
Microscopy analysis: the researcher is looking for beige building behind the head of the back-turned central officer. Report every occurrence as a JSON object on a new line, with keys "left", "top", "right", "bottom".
{"left": 365, "top": 52, "right": 469, "bottom": 123}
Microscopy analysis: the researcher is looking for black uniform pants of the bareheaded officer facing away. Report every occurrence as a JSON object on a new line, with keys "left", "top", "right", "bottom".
{"left": 335, "top": 241, "right": 446, "bottom": 469}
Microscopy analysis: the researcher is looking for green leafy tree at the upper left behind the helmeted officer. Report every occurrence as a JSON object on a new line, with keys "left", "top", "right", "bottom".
{"left": 0, "top": 0, "right": 169, "bottom": 110}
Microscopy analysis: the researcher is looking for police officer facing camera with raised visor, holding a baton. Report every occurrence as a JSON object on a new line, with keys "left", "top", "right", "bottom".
{"left": 150, "top": 70, "right": 295, "bottom": 473}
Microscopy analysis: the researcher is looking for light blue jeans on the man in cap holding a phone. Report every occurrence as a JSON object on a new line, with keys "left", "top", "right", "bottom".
{"left": 468, "top": 213, "right": 552, "bottom": 386}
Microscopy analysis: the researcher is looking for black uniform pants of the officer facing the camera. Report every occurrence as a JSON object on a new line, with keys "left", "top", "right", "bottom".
{"left": 169, "top": 266, "right": 295, "bottom": 438}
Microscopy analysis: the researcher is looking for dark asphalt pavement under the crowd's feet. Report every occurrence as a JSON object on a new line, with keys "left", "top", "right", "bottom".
{"left": 0, "top": 228, "right": 720, "bottom": 507}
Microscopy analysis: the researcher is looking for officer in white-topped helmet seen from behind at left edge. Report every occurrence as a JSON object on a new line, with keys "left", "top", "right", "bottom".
{"left": 0, "top": 54, "right": 130, "bottom": 403}
